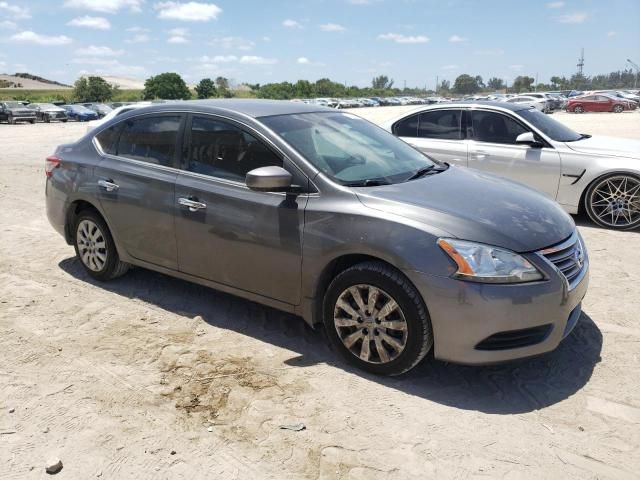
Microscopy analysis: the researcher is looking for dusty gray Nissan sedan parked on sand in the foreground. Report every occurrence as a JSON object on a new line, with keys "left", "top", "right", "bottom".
{"left": 45, "top": 100, "right": 588, "bottom": 375}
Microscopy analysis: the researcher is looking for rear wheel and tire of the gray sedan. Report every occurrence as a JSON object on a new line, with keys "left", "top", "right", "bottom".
{"left": 73, "top": 210, "right": 129, "bottom": 282}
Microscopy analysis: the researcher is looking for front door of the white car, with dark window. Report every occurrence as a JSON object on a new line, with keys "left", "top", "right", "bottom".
{"left": 467, "top": 109, "right": 560, "bottom": 199}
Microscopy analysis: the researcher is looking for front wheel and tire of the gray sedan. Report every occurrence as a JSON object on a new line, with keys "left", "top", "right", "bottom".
{"left": 323, "top": 261, "right": 433, "bottom": 375}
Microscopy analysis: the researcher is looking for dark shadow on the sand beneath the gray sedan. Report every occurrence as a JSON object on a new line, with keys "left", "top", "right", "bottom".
{"left": 59, "top": 257, "right": 602, "bottom": 414}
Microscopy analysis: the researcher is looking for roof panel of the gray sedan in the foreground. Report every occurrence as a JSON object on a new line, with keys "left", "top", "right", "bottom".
{"left": 132, "top": 98, "right": 335, "bottom": 118}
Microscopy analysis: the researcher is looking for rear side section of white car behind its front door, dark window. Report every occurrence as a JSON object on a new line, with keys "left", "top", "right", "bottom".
{"left": 393, "top": 108, "right": 467, "bottom": 167}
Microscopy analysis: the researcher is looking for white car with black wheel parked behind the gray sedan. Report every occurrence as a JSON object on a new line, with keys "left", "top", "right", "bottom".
{"left": 384, "top": 102, "right": 640, "bottom": 230}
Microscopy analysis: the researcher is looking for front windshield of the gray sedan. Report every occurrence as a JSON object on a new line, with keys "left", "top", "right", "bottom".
{"left": 260, "top": 112, "right": 436, "bottom": 186}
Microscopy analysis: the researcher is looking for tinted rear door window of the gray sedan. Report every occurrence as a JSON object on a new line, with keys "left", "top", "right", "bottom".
{"left": 117, "top": 115, "right": 182, "bottom": 167}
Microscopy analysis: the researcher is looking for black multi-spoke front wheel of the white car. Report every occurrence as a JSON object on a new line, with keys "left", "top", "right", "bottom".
{"left": 585, "top": 174, "right": 640, "bottom": 230}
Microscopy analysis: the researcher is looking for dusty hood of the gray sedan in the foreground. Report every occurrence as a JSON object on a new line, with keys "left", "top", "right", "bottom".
{"left": 353, "top": 167, "right": 575, "bottom": 252}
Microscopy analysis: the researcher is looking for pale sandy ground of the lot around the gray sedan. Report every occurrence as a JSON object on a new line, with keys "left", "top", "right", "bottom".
{"left": 0, "top": 109, "right": 640, "bottom": 480}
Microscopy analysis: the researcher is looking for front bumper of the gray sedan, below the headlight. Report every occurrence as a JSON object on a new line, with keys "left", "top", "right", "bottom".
{"left": 405, "top": 242, "right": 589, "bottom": 365}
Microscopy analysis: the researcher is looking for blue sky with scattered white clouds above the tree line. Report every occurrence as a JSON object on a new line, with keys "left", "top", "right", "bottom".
{"left": 0, "top": 0, "right": 640, "bottom": 88}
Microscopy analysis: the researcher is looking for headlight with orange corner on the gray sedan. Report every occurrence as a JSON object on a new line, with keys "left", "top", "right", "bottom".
{"left": 438, "top": 238, "right": 544, "bottom": 283}
